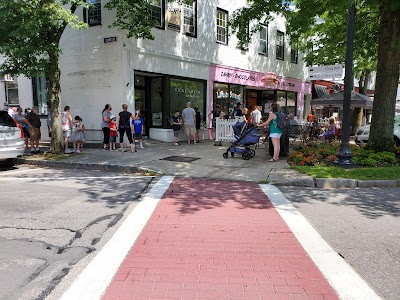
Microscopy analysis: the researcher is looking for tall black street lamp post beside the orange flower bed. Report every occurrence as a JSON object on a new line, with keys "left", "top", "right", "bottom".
{"left": 335, "top": 0, "right": 356, "bottom": 169}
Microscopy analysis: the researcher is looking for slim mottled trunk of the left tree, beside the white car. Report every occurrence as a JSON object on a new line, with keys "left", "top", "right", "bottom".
{"left": 46, "top": 53, "right": 64, "bottom": 154}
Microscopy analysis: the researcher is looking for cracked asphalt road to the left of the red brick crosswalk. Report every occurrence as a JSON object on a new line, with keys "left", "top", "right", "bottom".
{"left": 0, "top": 166, "right": 154, "bottom": 300}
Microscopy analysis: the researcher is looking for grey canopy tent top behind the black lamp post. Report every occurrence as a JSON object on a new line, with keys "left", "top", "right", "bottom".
{"left": 310, "top": 92, "right": 374, "bottom": 109}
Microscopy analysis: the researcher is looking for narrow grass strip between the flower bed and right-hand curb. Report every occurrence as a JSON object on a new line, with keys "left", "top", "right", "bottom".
{"left": 291, "top": 166, "right": 400, "bottom": 180}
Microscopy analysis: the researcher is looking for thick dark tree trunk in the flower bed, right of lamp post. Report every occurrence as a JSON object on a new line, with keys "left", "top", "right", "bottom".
{"left": 368, "top": 4, "right": 400, "bottom": 152}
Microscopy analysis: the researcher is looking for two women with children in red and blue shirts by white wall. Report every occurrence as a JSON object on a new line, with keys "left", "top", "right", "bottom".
{"left": 101, "top": 104, "right": 144, "bottom": 153}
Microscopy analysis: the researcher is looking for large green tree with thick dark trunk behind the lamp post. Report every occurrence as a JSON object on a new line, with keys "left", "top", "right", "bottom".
{"left": 230, "top": 0, "right": 400, "bottom": 151}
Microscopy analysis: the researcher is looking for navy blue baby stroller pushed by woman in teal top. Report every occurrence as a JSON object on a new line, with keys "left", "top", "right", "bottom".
{"left": 222, "top": 122, "right": 260, "bottom": 160}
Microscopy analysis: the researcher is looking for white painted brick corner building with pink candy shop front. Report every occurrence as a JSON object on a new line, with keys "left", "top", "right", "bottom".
{"left": 61, "top": 0, "right": 311, "bottom": 141}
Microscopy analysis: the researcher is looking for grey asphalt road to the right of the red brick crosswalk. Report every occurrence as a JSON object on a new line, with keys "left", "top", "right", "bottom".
{"left": 280, "top": 187, "right": 400, "bottom": 300}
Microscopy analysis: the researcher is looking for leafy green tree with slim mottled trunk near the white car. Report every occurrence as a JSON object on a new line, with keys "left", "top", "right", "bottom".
{"left": 0, "top": 0, "right": 154, "bottom": 153}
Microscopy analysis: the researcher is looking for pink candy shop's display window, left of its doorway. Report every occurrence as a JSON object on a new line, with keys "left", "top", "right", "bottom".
{"left": 214, "top": 83, "right": 244, "bottom": 115}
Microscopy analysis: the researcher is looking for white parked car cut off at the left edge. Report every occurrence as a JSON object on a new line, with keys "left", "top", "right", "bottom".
{"left": 0, "top": 111, "right": 25, "bottom": 167}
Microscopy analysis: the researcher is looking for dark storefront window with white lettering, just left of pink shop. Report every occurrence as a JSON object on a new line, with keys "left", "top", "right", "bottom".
{"left": 168, "top": 78, "right": 205, "bottom": 120}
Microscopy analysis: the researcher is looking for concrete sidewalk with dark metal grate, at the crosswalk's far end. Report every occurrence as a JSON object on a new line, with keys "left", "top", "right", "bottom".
{"left": 20, "top": 139, "right": 315, "bottom": 187}
